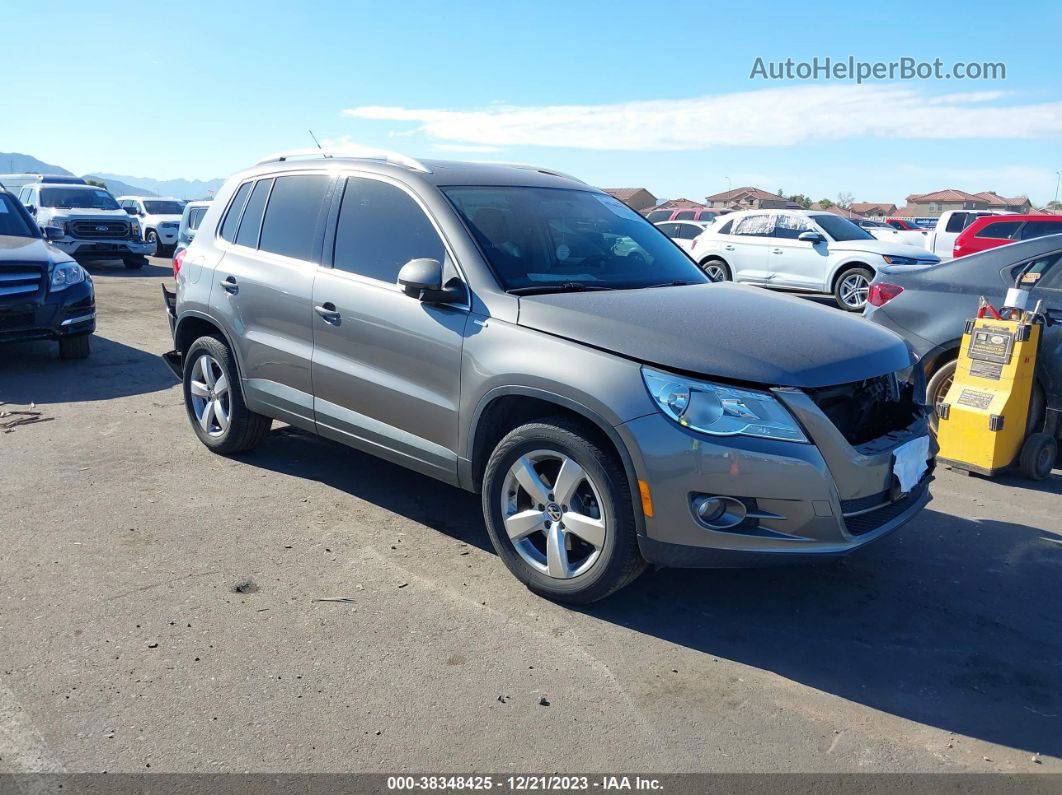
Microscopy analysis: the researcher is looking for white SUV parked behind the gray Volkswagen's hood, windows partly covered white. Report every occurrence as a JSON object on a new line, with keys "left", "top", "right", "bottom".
{"left": 693, "top": 210, "right": 940, "bottom": 312}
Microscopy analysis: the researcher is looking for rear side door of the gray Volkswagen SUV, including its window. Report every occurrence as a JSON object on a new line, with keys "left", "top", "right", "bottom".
{"left": 210, "top": 173, "right": 335, "bottom": 429}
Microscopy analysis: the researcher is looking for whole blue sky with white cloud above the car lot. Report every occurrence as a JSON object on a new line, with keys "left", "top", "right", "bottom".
{"left": 0, "top": 0, "right": 1062, "bottom": 204}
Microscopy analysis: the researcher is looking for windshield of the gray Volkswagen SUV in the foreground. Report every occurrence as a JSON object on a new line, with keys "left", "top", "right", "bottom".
{"left": 442, "top": 186, "right": 707, "bottom": 292}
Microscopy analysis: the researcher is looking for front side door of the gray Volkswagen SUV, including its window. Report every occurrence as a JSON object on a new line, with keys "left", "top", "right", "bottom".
{"left": 313, "top": 176, "right": 468, "bottom": 482}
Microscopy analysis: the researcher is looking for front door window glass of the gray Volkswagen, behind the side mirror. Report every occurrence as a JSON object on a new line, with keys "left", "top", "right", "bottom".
{"left": 333, "top": 176, "right": 446, "bottom": 284}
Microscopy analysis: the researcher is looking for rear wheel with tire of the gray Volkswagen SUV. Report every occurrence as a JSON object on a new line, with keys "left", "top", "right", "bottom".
{"left": 183, "top": 336, "right": 272, "bottom": 455}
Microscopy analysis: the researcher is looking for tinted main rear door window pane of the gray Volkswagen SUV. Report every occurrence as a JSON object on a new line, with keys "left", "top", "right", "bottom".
{"left": 258, "top": 174, "right": 331, "bottom": 260}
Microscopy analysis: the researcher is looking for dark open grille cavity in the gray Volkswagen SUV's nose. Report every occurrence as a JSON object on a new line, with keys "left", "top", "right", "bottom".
{"left": 806, "top": 373, "right": 920, "bottom": 446}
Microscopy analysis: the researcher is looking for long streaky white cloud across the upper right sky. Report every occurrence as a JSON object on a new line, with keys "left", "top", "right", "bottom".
{"left": 342, "top": 85, "right": 1062, "bottom": 151}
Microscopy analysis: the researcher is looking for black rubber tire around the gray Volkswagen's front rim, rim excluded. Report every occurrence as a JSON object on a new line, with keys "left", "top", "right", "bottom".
{"left": 482, "top": 422, "right": 640, "bottom": 604}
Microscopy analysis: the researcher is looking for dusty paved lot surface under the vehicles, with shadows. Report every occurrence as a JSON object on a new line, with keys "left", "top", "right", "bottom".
{"left": 0, "top": 260, "right": 1062, "bottom": 773}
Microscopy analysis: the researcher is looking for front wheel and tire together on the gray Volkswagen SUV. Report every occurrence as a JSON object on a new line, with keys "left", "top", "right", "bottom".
{"left": 482, "top": 417, "right": 646, "bottom": 604}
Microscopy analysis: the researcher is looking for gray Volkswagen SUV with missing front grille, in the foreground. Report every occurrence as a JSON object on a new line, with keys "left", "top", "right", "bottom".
{"left": 164, "top": 151, "right": 932, "bottom": 603}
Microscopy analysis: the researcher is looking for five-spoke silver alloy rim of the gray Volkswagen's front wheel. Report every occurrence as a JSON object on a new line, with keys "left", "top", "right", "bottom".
{"left": 501, "top": 450, "right": 609, "bottom": 580}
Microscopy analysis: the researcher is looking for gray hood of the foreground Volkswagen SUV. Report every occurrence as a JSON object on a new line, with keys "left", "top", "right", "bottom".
{"left": 517, "top": 282, "right": 911, "bottom": 387}
